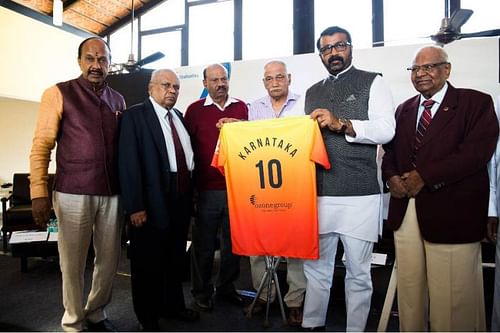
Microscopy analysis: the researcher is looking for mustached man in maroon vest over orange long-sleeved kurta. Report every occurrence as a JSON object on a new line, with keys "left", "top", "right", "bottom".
{"left": 30, "top": 37, "right": 125, "bottom": 331}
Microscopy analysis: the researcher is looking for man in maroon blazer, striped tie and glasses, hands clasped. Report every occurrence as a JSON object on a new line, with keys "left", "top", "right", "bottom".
{"left": 382, "top": 46, "right": 498, "bottom": 331}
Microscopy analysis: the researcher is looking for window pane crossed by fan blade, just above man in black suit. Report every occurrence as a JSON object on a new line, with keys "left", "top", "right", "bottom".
{"left": 141, "top": 30, "right": 182, "bottom": 69}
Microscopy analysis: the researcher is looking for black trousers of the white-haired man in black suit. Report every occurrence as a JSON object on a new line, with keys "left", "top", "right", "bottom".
{"left": 129, "top": 198, "right": 190, "bottom": 329}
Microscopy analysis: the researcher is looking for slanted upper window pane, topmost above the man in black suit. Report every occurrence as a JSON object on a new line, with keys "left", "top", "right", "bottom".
{"left": 141, "top": 0, "right": 184, "bottom": 31}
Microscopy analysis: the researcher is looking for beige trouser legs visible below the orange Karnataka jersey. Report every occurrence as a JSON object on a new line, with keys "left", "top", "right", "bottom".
{"left": 250, "top": 256, "right": 306, "bottom": 308}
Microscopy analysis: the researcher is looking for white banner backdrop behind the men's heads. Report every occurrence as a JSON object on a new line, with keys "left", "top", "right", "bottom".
{"left": 177, "top": 38, "right": 500, "bottom": 111}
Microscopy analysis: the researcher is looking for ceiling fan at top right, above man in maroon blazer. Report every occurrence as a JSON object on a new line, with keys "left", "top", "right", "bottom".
{"left": 430, "top": 8, "right": 500, "bottom": 45}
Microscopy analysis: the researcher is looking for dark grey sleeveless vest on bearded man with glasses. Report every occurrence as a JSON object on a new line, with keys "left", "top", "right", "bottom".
{"left": 305, "top": 67, "right": 380, "bottom": 196}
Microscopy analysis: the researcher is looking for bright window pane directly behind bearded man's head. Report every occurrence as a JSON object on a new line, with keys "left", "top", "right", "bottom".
{"left": 314, "top": 0, "right": 372, "bottom": 49}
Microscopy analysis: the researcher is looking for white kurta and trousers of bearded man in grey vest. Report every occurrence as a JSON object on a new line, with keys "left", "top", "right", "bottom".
{"left": 302, "top": 69, "right": 395, "bottom": 331}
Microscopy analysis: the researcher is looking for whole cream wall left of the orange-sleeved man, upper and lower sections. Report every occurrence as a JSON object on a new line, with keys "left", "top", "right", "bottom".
{"left": 0, "top": 7, "right": 83, "bottom": 184}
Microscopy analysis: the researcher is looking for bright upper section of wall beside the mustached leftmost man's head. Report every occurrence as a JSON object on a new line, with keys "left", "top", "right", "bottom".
{"left": 0, "top": 7, "right": 83, "bottom": 101}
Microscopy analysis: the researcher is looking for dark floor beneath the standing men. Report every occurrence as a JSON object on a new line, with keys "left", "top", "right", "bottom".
{"left": 0, "top": 236, "right": 494, "bottom": 332}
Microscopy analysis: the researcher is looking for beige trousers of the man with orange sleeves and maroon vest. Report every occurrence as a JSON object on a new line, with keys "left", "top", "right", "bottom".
{"left": 53, "top": 191, "right": 123, "bottom": 331}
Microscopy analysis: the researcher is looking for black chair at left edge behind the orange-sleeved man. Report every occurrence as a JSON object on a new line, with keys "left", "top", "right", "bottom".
{"left": 2, "top": 173, "right": 55, "bottom": 252}
